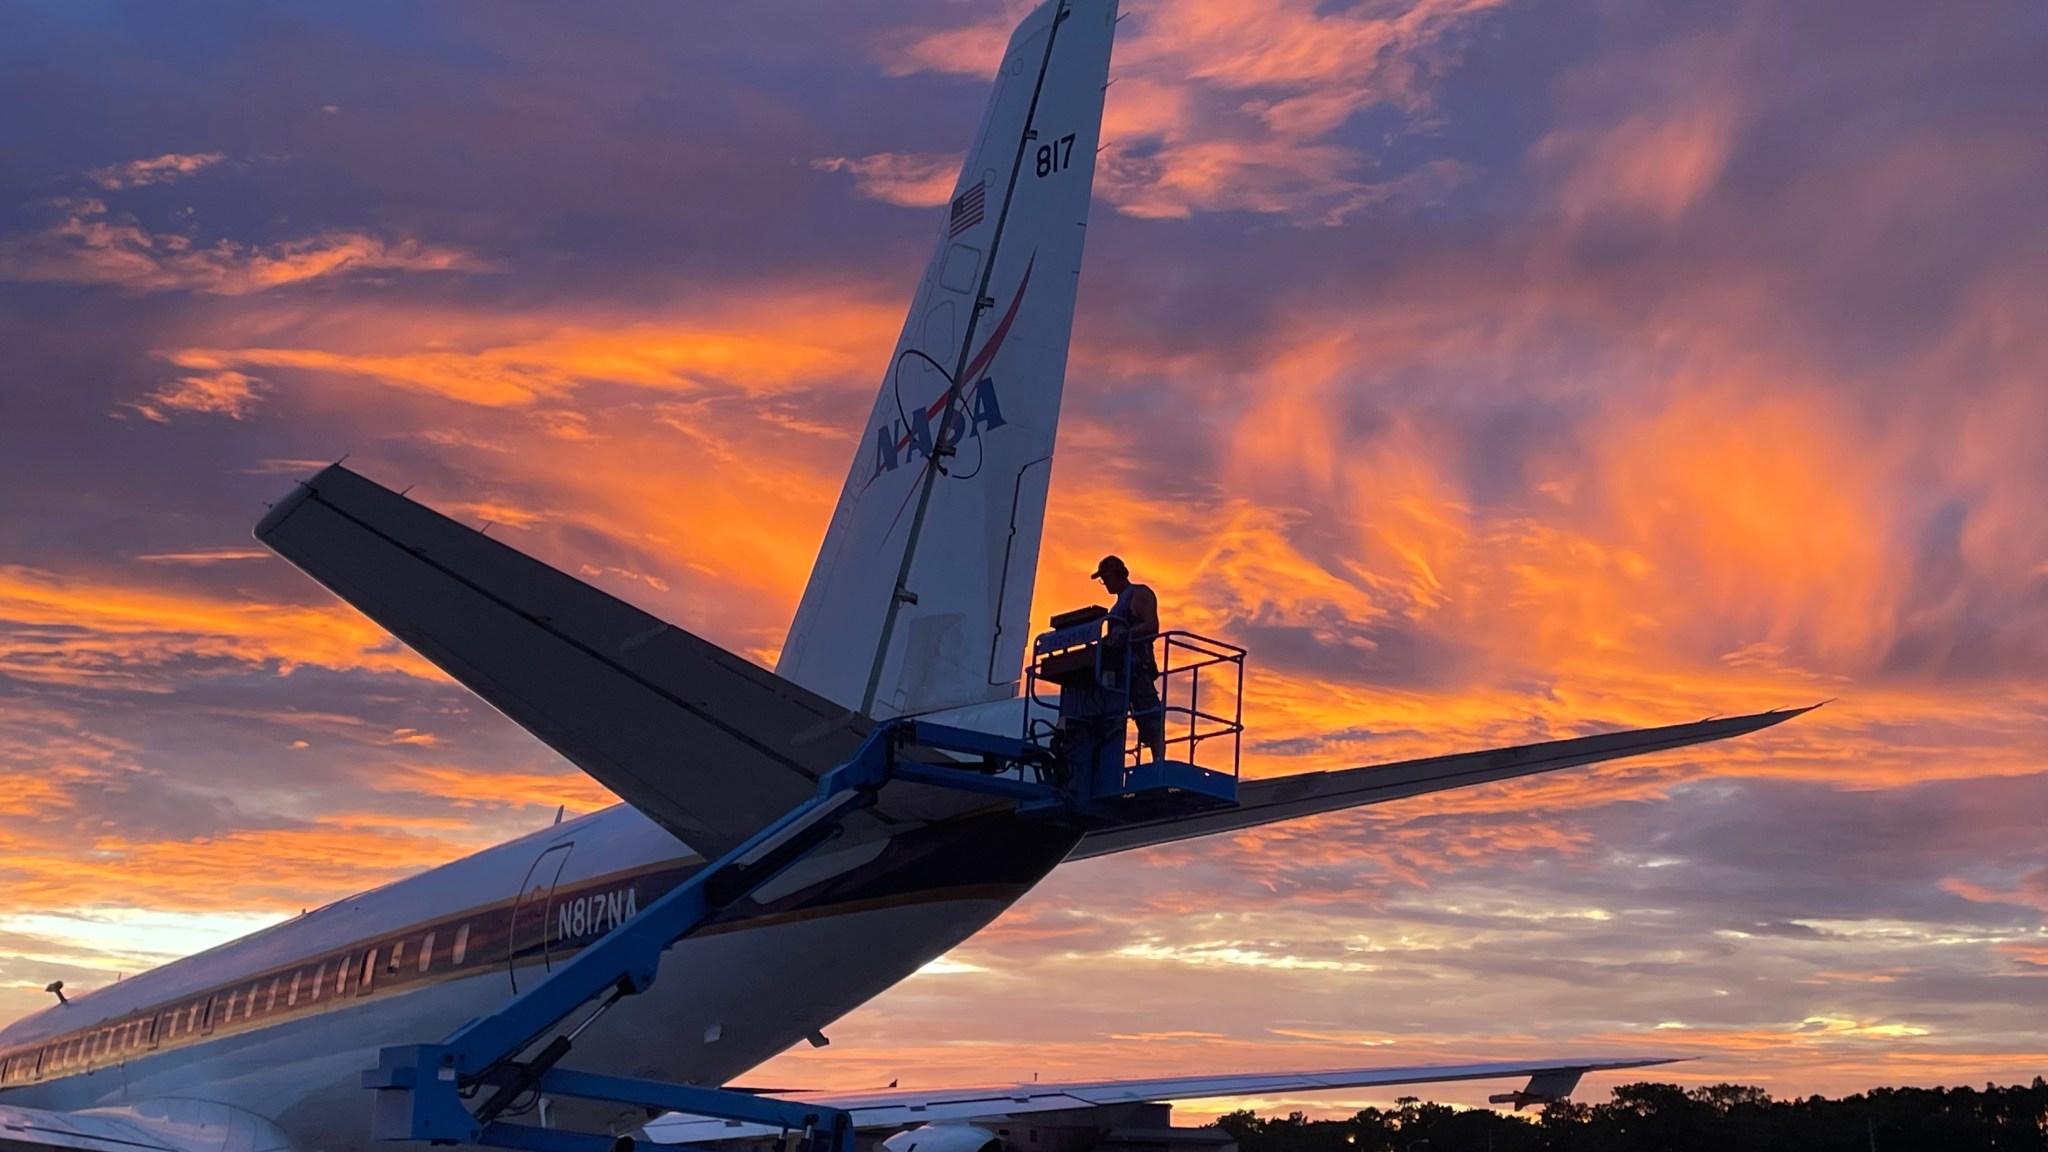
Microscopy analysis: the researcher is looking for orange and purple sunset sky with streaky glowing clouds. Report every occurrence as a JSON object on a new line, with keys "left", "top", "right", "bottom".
{"left": 0, "top": 0, "right": 2048, "bottom": 1111}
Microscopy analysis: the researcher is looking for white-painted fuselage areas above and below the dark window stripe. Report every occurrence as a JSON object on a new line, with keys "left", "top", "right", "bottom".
{"left": 0, "top": 806, "right": 1022, "bottom": 1152}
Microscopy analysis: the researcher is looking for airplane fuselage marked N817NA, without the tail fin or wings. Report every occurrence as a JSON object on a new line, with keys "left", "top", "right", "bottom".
{"left": 0, "top": 806, "right": 1077, "bottom": 1150}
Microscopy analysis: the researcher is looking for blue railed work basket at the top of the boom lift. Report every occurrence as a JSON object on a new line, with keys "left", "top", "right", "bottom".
{"left": 1024, "top": 605, "right": 1245, "bottom": 822}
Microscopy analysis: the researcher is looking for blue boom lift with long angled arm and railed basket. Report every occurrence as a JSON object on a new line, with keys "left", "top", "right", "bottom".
{"left": 362, "top": 623, "right": 1245, "bottom": 1152}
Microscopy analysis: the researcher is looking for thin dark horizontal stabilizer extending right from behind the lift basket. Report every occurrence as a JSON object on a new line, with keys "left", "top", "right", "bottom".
{"left": 1067, "top": 705, "right": 1819, "bottom": 861}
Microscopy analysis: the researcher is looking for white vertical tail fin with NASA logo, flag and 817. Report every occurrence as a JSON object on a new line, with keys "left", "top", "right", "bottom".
{"left": 776, "top": 0, "right": 1116, "bottom": 717}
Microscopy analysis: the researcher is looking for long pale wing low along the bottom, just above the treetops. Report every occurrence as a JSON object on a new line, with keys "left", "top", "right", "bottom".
{"left": 645, "top": 1056, "right": 1677, "bottom": 1144}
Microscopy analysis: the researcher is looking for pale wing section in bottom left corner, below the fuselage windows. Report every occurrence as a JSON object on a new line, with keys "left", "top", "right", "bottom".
{"left": 0, "top": 1099, "right": 291, "bottom": 1152}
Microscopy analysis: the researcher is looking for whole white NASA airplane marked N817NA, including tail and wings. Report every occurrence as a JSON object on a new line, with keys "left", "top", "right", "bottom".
{"left": 0, "top": 0, "right": 1804, "bottom": 1152}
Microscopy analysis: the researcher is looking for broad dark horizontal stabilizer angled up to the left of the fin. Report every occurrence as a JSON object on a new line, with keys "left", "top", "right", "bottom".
{"left": 256, "top": 465, "right": 973, "bottom": 859}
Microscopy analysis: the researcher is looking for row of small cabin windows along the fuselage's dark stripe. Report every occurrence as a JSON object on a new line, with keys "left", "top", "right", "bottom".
{"left": 0, "top": 924, "right": 481, "bottom": 1086}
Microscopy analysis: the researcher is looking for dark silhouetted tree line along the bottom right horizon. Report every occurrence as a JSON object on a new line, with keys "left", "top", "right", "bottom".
{"left": 1217, "top": 1076, "right": 2048, "bottom": 1152}
